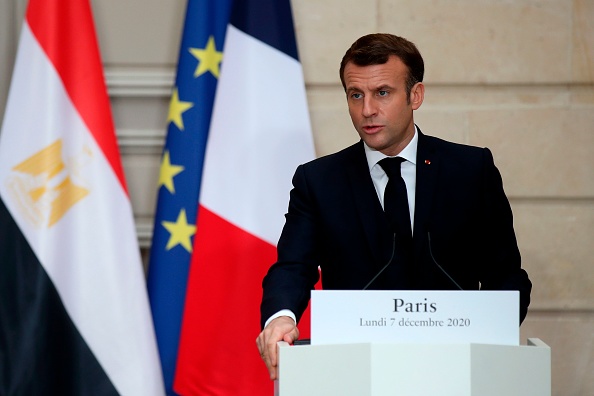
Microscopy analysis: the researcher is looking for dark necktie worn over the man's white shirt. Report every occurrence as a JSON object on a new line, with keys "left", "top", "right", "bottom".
{"left": 379, "top": 157, "right": 412, "bottom": 241}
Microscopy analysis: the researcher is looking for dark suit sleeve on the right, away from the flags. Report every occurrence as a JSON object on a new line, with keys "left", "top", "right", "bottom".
{"left": 480, "top": 149, "right": 532, "bottom": 323}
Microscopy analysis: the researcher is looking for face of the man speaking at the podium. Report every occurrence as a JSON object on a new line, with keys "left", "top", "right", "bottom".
{"left": 344, "top": 56, "right": 424, "bottom": 156}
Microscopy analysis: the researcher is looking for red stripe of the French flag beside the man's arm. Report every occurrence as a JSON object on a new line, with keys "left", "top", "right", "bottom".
{"left": 174, "top": 206, "right": 310, "bottom": 396}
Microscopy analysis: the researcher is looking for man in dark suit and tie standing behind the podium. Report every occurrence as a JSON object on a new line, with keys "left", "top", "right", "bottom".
{"left": 256, "top": 34, "right": 531, "bottom": 379}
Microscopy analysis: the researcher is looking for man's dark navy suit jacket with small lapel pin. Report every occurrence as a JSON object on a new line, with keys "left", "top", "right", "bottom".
{"left": 261, "top": 131, "right": 532, "bottom": 325}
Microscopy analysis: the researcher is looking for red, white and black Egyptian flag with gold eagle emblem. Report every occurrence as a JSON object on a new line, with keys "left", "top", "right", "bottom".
{"left": 0, "top": 0, "right": 164, "bottom": 396}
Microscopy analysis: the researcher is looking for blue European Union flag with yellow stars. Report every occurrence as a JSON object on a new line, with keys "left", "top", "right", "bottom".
{"left": 148, "top": 0, "right": 232, "bottom": 395}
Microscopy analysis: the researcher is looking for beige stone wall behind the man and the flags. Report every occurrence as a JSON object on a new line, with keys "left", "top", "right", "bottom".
{"left": 0, "top": 0, "right": 594, "bottom": 396}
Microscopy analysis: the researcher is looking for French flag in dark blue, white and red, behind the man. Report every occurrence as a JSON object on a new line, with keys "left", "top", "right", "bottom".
{"left": 151, "top": 0, "right": 314, "bottom": 396}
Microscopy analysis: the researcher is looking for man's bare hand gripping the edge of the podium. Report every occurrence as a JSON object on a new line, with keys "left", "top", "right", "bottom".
{"left": 256, "top": 316, "right": 299, "bottom": 380}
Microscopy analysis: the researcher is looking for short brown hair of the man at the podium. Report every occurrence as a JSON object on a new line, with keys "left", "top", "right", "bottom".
{"left": 340, "top": 33, "right": 425, "bottom": 97}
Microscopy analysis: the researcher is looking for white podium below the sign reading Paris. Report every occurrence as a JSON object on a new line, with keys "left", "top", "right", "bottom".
{"left": 274, "top": 338, "right": 551, "bottom": 396}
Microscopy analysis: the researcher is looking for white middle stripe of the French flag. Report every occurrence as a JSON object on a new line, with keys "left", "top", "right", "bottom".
{"left": 200, "top": 25, "right": 315, "bottom": 245}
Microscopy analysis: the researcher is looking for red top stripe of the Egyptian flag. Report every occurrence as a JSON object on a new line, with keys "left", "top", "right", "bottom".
{"left": 26, "top": 0, "right": 127, "bottom": 191}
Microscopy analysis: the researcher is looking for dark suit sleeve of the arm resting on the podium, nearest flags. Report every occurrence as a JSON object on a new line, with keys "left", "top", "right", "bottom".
{"left": 260, "top": 165, "right": 319, "bottom": 327}
